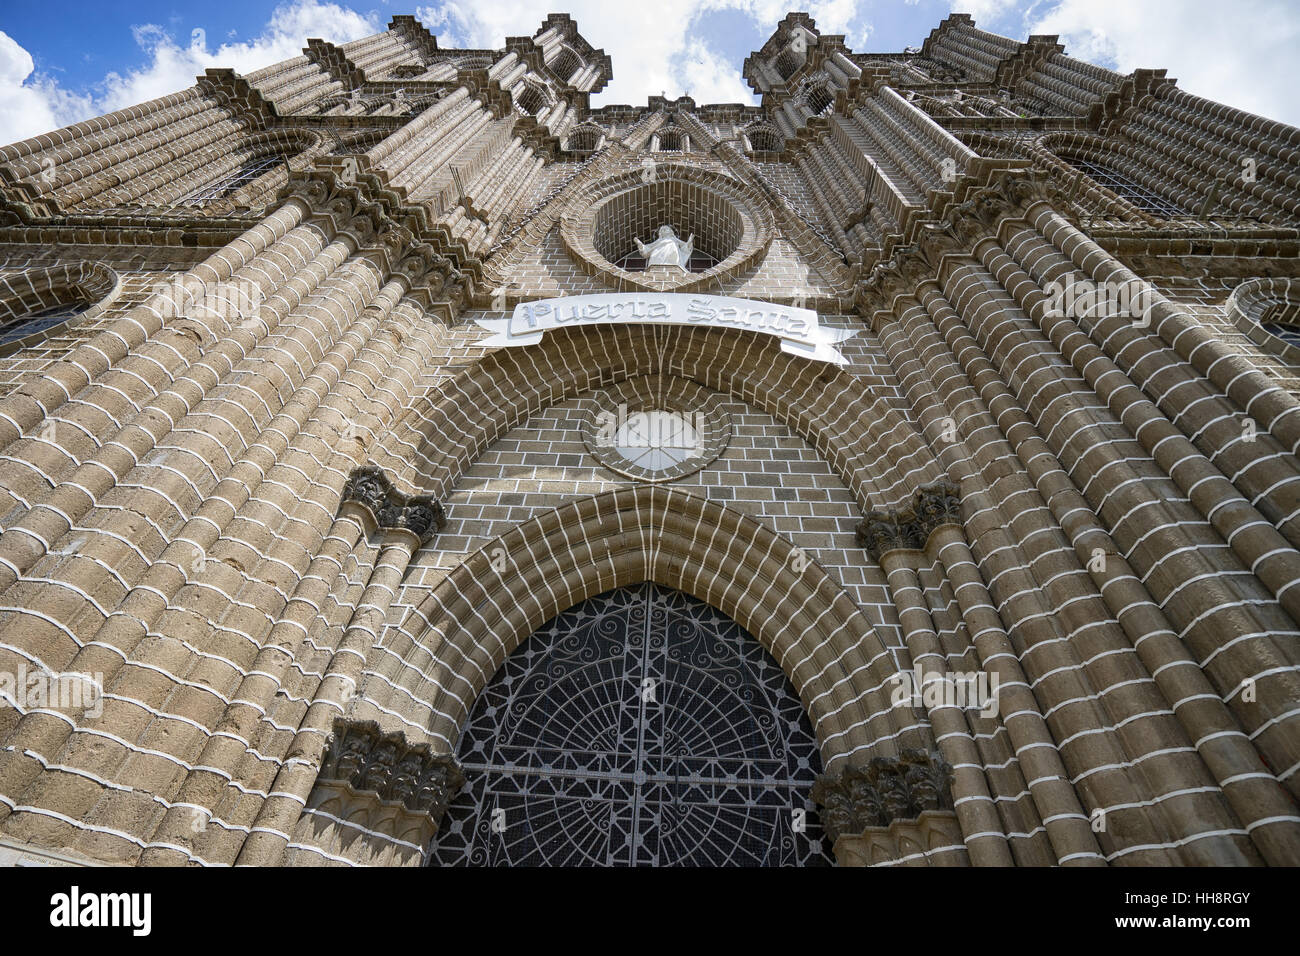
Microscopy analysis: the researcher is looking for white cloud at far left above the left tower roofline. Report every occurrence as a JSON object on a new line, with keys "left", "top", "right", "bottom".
{"left": 0, "top": 0, "right": 385, "bottom": 143}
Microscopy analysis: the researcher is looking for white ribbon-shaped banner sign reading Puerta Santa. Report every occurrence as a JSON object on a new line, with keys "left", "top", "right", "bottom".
{"left": 478, "top": 293, "right": 854, "bottom": 365}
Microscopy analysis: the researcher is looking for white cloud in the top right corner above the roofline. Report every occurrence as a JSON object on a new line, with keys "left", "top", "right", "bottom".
{"left": 1030, "top": 0, "right": 1300, "bottom": 125}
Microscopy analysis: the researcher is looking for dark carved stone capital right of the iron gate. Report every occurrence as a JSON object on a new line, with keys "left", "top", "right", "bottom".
{"left": 813, "top": 750, "right": 953, "bottom": 840}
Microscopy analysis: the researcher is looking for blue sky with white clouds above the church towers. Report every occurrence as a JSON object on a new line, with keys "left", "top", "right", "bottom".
{"left": 0, "top": 0, "right": 1300, "bottom": 143}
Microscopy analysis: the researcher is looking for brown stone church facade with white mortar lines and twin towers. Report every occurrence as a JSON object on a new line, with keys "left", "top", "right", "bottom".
{"left": 0, "top": 13, "right": 1300, "bottom": 866}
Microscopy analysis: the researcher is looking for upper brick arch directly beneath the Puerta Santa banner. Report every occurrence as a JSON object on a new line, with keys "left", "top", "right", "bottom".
{"left": 376, "top": 319, "right": 944, "bottom": 511}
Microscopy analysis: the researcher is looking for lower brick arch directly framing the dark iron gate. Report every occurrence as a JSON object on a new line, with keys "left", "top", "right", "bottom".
{"left": 355, "top": 485, "right": 928, "bottom": 771}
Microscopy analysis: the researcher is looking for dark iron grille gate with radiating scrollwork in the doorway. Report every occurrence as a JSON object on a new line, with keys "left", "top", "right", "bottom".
{"left": 430, "top": 583, "right": 831, "bottom": 866}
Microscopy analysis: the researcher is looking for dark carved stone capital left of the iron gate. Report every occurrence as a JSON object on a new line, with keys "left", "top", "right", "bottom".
{"left": 317, "top": 718, "right": 465, "bottom": 822}
